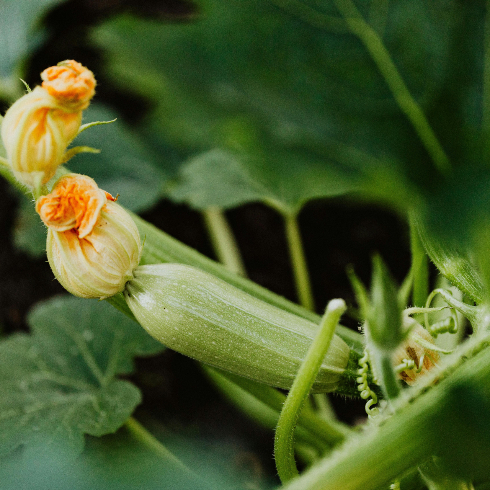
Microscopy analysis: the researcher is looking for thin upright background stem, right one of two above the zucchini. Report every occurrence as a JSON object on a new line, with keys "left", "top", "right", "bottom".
{"left": 283, "top": 212, "right": 315, "bottom": 311}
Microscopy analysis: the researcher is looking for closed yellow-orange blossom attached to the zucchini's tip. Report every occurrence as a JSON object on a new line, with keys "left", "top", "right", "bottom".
{"left": 36, "top": 174, "right": 141, "bottom": 299}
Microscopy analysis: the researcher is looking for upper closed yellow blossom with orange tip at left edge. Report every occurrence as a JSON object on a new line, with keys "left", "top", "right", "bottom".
{"left": 1, "top": 60, "right": 96, "bottom": 189}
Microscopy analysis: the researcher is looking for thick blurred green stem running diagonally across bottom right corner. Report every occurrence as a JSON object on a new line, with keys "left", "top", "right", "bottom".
{"left": 283, "top": 336, "right": 490, "bottom": 490}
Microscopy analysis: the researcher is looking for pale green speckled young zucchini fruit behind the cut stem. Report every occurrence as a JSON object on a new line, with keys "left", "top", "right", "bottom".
{"left": 124, "top": 263, "right": 357, "bottom": 394}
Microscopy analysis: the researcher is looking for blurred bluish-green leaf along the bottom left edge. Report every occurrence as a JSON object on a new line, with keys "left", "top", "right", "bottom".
{"left": 0, "top": 428, "right": 273, "bottom": 490}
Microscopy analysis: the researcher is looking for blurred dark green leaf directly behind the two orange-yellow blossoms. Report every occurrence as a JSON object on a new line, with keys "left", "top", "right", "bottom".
{"left": 67, "top": 103, "right": 165, "bottom": 211}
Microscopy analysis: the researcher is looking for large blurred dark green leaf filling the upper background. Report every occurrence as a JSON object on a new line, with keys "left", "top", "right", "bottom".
{"left": 90, "top": 0, "right": 462, "bottom": 210}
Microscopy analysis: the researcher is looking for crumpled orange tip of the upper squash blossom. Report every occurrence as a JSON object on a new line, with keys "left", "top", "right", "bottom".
{"left": 41, "top": 60, "right": 96, "bottom": 112}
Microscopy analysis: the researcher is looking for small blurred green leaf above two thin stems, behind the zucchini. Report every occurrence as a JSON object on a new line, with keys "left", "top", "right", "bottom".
{"left": 169, "top": 149, "right": 352, "bottom": 212}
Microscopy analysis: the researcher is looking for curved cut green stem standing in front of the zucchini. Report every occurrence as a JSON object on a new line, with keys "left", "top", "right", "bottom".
{"left": 274, "top": 299, "right": 346, "bottom": 483}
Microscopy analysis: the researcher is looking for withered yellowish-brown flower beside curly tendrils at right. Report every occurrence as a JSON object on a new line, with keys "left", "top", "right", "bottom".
{"left": 393, "top": 319, "right": 439, "bottom": 385}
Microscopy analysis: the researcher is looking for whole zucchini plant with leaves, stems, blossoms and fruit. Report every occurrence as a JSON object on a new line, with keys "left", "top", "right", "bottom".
{"left": 0, "top": 0, "right": 490, "bottom": 490}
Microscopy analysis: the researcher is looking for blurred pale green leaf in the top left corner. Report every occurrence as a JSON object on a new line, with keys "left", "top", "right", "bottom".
{"left": 0, "top": 0, "right": 64, "bottom": 98}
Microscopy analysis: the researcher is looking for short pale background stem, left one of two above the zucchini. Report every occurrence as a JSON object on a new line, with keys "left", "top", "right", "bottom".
{"left": 203, "top": 206, "right": 247, "bottom": 276}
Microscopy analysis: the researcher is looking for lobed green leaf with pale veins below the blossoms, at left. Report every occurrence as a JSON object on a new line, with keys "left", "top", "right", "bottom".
{"left": 0, "top": 297, "right": 162, "bottom": 456}
